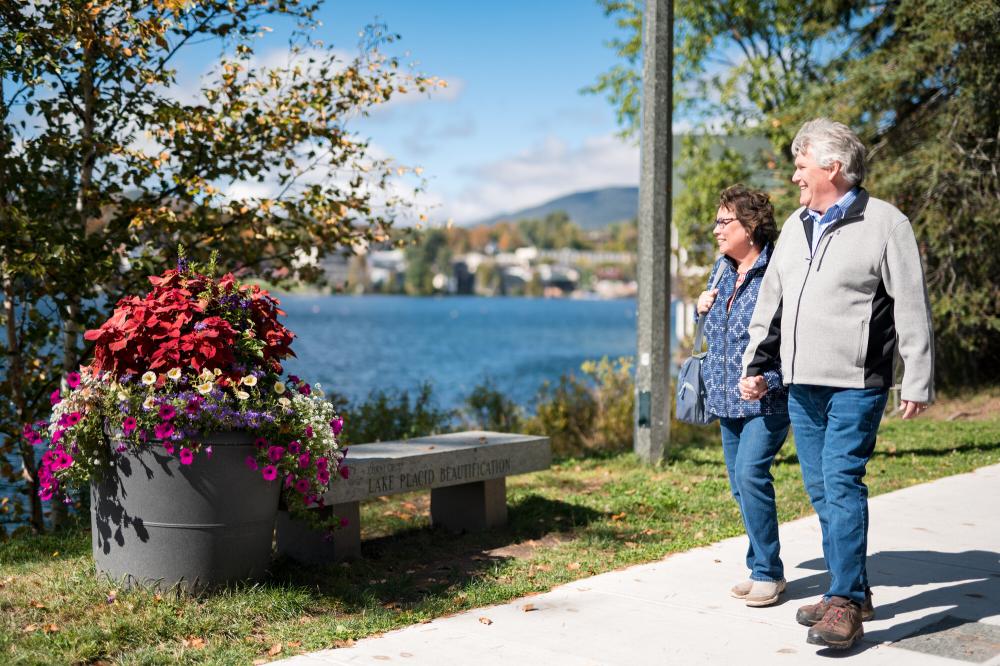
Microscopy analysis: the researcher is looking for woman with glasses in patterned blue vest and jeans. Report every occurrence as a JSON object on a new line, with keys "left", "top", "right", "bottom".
{"left": 697, "top": 185, "right": 788, "bottom": 606}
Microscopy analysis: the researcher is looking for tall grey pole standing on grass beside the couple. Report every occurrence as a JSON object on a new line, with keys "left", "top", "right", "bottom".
{"left": 633, "top": 0, "right": 674, "bottom": 463}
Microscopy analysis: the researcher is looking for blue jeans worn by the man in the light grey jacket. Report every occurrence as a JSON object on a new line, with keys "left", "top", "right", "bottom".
{"left": 788, "top": 384, "right": 889, "bottom": 604}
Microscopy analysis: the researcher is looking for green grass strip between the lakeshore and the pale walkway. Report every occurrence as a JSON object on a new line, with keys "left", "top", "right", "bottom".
{"left": 0, "top": 417, "right": 1000, "bottom": 664}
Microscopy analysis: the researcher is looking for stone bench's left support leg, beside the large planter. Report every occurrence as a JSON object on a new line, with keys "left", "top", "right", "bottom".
{"left": 277, "top": 502, "right": 361, "bottom": 564}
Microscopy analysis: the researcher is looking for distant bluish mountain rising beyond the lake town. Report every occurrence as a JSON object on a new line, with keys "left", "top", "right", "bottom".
{"left": 476, "top": 187, "right": 639, "bottom": 229}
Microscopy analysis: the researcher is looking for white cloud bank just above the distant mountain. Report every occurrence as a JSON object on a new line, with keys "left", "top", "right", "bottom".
{"left": 432, "top": 135, "right": 639, "bottom": 223}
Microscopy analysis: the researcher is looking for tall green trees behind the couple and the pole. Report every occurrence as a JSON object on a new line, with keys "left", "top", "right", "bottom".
{"left": 589, "top": 0, "right": 1000, "bottom": 385}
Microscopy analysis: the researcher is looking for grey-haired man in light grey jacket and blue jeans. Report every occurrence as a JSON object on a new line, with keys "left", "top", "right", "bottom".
{"left": 740, "top": 118, "right": 933, "bottom": 649}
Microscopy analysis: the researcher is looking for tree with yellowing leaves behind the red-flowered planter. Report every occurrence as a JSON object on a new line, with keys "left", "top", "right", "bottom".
{"left": 0, "top": 0, "right": 443, "bottom": 529}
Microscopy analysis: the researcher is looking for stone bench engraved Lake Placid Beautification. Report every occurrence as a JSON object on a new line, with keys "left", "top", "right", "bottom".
{"left": 277, "top": 431, "right": 552, "bottom": 562}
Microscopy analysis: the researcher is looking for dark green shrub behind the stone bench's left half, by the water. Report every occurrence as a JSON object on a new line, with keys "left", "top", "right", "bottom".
{"left": 331, "top": 382, "right": 453, "bottom": 446}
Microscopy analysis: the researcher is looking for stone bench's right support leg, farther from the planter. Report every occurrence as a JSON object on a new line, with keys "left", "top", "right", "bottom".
{"left": 431, "top": 478, "right": 507, "bottom": 532}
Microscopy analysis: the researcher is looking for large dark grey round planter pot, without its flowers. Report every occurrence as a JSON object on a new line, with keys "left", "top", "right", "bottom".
{"left": 90, "top": 432, "right": 281, "bottom": 592}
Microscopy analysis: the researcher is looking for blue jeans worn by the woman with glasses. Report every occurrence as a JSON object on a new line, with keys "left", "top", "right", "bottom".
{"left": 719, "top": 414, "right": 788, "bottom": 581}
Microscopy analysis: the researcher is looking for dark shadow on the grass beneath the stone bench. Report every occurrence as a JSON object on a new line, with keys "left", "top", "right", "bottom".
{"left": 270, "top": 495, "right": 603, "bottom": 612}
